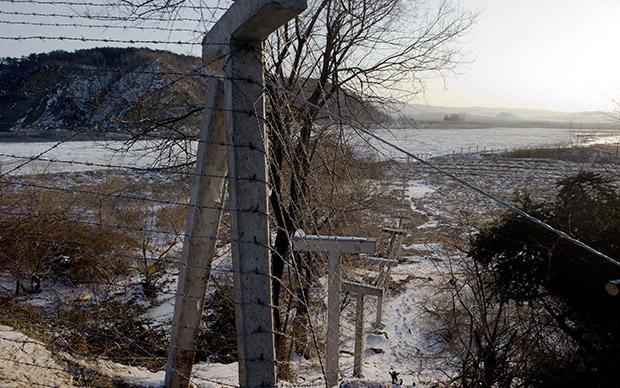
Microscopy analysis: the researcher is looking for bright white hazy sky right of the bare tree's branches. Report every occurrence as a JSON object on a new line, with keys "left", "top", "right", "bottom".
{"left": 426, "top": 0, "right": 620, "bottom": 111}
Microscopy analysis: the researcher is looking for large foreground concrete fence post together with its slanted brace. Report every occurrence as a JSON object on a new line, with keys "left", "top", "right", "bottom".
{"left": 166, "top": 0, "right": 306, "bottom": 387}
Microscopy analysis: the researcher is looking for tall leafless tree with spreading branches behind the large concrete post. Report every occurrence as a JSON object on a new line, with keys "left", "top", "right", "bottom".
{"left": 112, "top": 0, "right": 475, "bottom": 356}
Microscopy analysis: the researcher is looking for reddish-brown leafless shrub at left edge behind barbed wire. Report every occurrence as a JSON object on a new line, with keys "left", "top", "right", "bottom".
{"left": 0, "top": 183, "right": 131, "bottom": 295}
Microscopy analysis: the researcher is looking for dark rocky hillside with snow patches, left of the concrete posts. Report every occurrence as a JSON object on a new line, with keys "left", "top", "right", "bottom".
{"left": 0, "top": 48, "right": 207, "bottom": 132}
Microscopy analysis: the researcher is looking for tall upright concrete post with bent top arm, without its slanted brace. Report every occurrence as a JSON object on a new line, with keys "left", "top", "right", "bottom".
{"left": 208, "top": 0, "right": 306, "bottom": 387}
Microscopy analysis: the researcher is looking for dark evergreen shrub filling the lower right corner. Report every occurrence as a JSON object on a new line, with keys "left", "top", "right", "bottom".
{"left": 455, "top": 172, "right": 620, "bottom": 387}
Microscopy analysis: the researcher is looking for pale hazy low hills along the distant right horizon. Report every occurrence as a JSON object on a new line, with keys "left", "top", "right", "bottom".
{"left": 399, "top": 104, "right": 618, "bottom": 127}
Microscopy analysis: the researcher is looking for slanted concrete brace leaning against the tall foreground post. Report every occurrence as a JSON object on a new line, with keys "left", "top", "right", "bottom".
{"left": 166, "top": 79, "right": 227, "bottom": 387}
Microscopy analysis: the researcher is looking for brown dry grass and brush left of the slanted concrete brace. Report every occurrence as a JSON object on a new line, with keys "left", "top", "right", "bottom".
{"left": 0, "top": 168, "right": 187, "bottom": 374}
